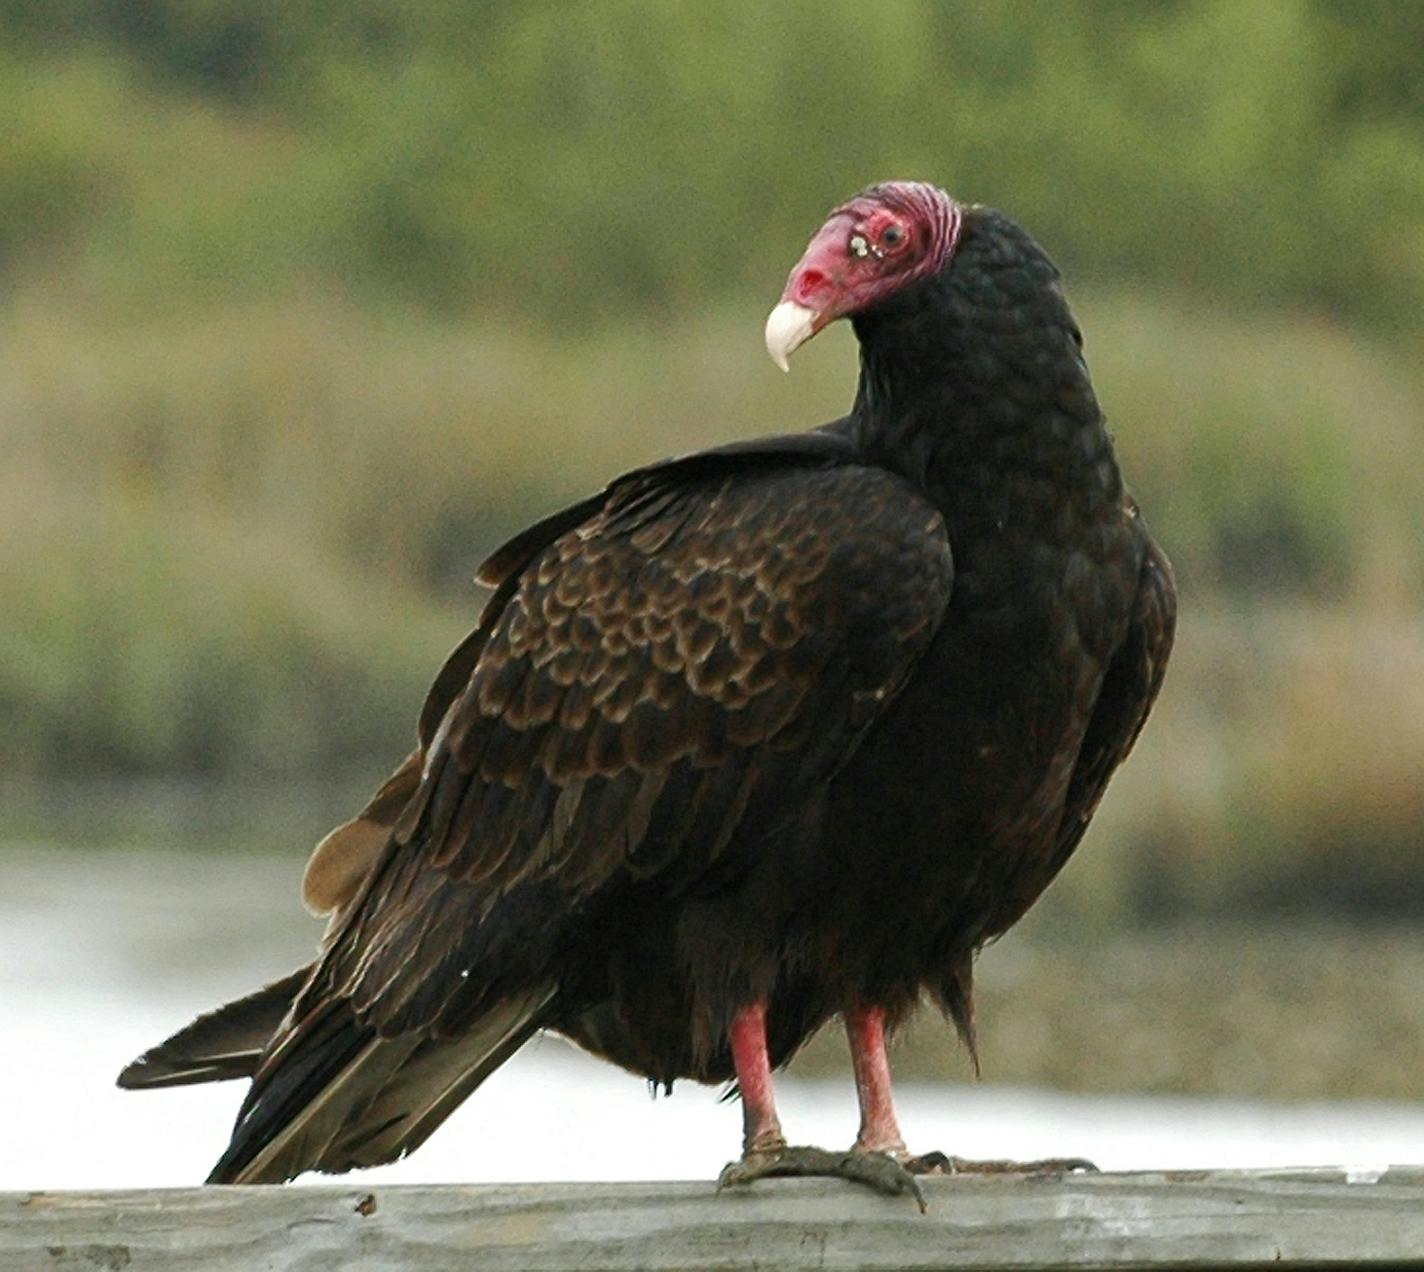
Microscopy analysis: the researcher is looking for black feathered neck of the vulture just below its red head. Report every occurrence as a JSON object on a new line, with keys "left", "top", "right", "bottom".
{"left": 852, "top": 235, "right": 1124, "bottom": 541}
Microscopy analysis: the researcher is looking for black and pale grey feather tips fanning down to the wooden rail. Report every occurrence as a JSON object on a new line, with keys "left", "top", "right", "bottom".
{"left": 208, "top": 987, "right": 554, "bottom": 1184}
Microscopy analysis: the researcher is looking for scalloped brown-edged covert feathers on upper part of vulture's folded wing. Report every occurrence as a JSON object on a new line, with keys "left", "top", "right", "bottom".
{"left": 427, "top": 467, "right": 950, "bottom": 886}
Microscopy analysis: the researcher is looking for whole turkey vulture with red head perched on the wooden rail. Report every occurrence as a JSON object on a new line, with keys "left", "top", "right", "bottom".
{"left": 120, "top": 182, "right": 1175, "bottom": 1191}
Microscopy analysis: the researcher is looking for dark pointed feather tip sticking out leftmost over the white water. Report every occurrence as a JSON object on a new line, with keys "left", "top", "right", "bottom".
{"left": 118, "top": 964, "right": 312, "bottom": 1091}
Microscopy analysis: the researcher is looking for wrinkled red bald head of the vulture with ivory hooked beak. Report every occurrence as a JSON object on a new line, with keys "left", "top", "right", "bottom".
{"left": 766, "top": 181, "right": 963, "bottom": 370}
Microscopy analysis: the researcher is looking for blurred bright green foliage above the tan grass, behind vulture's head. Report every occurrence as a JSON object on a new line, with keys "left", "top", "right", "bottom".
{"left": 0, "top": 0, "right": 1424, "bottom": 323}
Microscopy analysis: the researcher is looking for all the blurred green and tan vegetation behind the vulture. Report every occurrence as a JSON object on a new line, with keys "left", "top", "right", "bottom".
{"left": 0, "top": 0, "right": 1424, "bottom": 1088}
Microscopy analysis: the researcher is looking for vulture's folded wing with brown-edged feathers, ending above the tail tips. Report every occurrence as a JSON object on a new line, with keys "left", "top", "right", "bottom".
{"left": 298, "top": 467, "right": 951, "bottom": 1030}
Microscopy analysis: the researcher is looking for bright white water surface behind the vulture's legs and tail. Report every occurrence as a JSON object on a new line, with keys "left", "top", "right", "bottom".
{"left": 0, "top": 849, "right": 1424, "bottom": 1189}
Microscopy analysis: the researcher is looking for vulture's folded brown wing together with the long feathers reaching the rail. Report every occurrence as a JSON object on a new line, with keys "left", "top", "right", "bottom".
{"left": 211, "top": 450, "right": 951, "bottom": 1182}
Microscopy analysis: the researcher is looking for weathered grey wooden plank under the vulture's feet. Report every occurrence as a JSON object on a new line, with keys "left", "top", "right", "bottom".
{"left": 8, "top": 1168, "right": 1424, "bottom": 1272}
